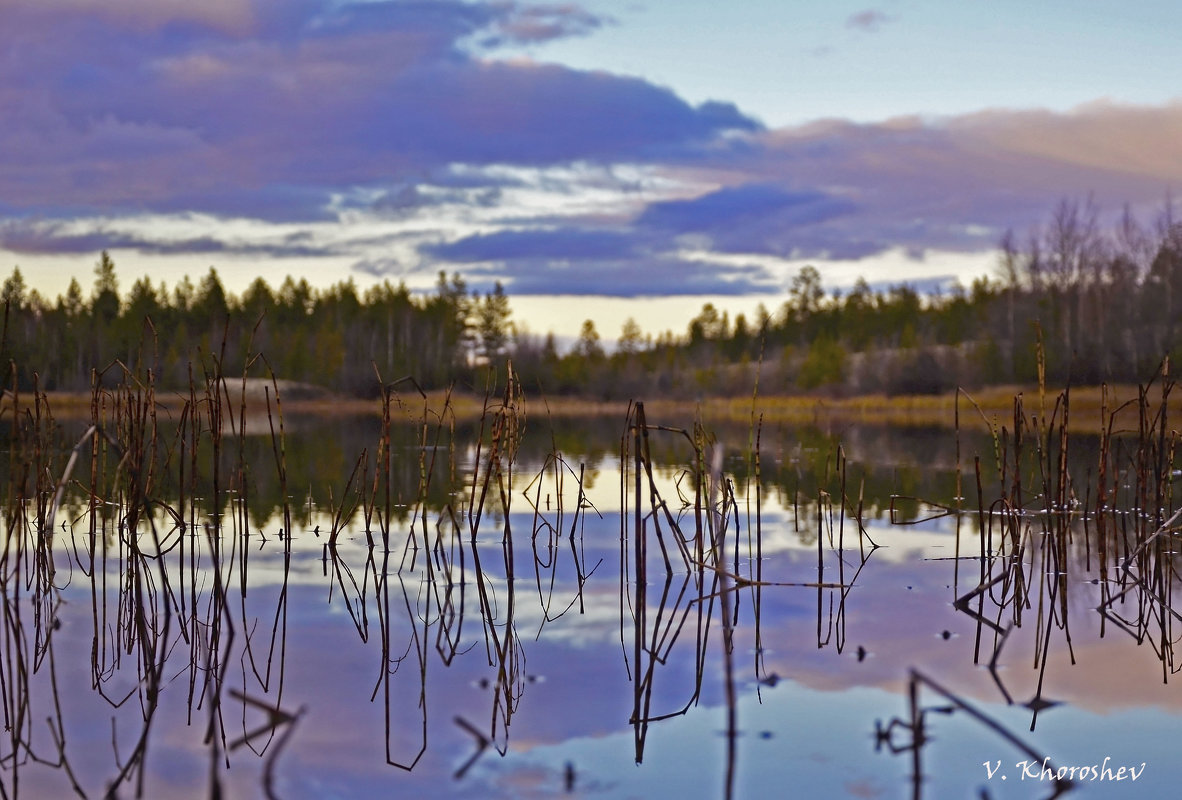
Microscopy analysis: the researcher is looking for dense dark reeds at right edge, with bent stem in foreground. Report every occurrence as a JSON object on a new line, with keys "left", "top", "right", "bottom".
{"left": 876, "top": 364, "right": 1182, "bottom": 798}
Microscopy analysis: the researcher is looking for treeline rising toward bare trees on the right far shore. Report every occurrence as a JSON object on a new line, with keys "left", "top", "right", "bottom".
{"left": 515, "top": 194, "right": 1182, "bottom": 397}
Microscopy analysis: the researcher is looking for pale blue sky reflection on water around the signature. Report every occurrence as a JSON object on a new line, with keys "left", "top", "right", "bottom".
{"left": 456, "top": 683, "right": 1178, "bottom": 798}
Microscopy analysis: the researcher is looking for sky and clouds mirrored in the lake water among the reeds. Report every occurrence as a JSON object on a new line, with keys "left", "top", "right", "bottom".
{"left": 6, "top": 446, "right": 1182, "bottom": 798}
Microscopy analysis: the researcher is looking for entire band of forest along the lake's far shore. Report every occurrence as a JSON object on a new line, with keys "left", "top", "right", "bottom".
{"left": 0, "top": 199, "right": 1182, "bottom": 399}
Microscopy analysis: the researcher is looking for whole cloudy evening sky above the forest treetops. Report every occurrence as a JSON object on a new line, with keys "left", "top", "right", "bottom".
{"left": 0, "top": 0, "right": 1182, "bottom": 339}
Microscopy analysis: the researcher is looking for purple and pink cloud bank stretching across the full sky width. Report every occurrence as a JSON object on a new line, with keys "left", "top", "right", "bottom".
{"left": 0, "top": 0, "right": 1182, "bottom": 295}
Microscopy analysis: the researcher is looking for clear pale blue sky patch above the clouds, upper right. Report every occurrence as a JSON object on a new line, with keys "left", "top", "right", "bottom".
{"left": 522, "top": 0, "right": 1182, "bottom": 126}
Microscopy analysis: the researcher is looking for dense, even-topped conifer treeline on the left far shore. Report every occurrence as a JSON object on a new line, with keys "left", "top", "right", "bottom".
{"left": 2, "top": 252, "right": 509, "bottom": 395}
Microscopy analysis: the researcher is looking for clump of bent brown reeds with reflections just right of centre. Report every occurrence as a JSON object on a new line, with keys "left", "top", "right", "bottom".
{"left": 619, "top": 403, "right": 877, "bottom": 798}
